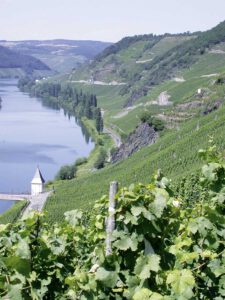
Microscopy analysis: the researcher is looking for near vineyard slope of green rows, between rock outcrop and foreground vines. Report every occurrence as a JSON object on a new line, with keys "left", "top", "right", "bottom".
{"left": 45, "top": 96, "right": 225, "bottom": 222}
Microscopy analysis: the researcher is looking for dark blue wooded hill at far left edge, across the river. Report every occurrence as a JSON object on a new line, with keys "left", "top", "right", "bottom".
{"left": 0, "top": 46, "right": 50, "bottom": 74}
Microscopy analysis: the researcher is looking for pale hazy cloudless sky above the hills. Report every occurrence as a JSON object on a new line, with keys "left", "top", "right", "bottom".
{"left": 0, "top": 0, "right": 225, "bottom": 42}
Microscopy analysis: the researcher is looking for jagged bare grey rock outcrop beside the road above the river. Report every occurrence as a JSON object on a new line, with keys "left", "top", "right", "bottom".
{"left": 111, "top": 123, "right": 158, "bottom": 163}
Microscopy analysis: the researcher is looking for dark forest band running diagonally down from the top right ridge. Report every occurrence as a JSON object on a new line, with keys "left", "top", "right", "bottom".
{"left": 122, "top": 22, "right": 225, "bottom": 106}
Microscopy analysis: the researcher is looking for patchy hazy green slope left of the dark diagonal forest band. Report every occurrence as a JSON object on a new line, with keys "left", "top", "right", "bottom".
{"left": 71, "top": 34, "right": 193, "bottom": 89}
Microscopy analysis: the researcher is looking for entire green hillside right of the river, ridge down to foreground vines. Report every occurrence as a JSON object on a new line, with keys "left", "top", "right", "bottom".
{"left": 17, "top": 22, "right": 225, "bottom": 222}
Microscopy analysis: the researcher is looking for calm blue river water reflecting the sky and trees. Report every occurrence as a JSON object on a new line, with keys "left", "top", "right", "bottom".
{"left": 0, "top": 79, "right": 94, "bottom": 213}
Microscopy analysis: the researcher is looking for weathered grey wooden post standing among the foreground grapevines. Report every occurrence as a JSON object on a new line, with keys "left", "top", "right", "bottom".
{"left": 105, "top": 181, "right": 118, "bottom": 256}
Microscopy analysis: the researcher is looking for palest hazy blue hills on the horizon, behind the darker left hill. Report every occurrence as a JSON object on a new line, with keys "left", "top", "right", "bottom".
{"left": 0, "top": 39, "right": 111, "bottom": 73}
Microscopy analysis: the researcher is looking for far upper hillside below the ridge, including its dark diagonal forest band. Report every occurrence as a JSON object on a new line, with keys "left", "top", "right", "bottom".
{"left": 70, "top": 22, "right": 225, "bottom": 106}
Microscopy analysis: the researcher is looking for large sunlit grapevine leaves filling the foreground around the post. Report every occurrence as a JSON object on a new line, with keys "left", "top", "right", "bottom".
{"left": 0, "top": 146, "right": 225, "bottom": 300}
